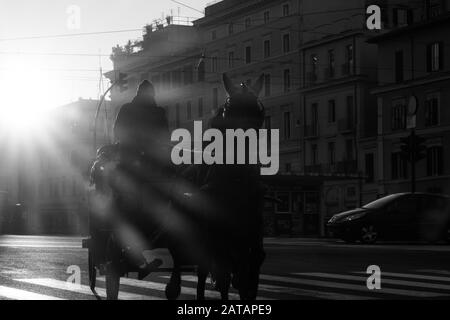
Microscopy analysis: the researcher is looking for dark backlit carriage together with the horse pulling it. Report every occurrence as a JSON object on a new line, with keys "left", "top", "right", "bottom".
{"left": 83, "top": 74, "right": 264, "bottom": 299}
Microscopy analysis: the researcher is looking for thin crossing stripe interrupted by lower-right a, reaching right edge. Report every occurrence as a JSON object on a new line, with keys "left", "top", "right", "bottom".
{"left": 294, "top": 272, "right": 450, "bottom": 290}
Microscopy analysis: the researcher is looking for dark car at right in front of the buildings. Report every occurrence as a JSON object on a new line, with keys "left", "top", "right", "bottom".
{"left": 327, "top": 193, "right": 450, "bottom": 244}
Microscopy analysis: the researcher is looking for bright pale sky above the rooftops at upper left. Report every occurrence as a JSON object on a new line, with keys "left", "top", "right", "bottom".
{"left": 0, "top": 0, "right": 211, "bottom": 116}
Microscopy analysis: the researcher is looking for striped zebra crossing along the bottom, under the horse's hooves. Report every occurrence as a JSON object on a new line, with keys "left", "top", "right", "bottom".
{"left": 0, "top": 270, "right": 450, "bottom": 300}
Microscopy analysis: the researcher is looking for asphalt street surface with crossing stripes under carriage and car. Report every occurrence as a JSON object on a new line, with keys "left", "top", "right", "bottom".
{"left": 0, "top": 236, "right": 450, "bottom": 300}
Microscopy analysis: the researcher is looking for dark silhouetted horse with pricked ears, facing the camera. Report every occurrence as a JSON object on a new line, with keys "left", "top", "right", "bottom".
{"left": 168, "top": 74, "right": 265, "bottom": 300}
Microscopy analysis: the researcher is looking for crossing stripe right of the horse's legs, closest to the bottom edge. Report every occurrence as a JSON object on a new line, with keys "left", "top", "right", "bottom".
{"left": 163, "top": 275, "right": 375, "bottom": 300}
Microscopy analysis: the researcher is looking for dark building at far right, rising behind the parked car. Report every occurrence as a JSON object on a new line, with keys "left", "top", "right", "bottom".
{"left": 370, "top": 6, "right": 450, "bottom": 196}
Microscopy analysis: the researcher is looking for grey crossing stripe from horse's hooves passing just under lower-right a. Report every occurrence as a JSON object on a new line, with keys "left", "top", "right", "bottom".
{"left": 261, "top": 275, "right": 442, "bottom": 298}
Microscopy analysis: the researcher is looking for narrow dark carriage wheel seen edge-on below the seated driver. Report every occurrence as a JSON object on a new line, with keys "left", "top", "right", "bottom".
{"left": 106, "top": 235, "right": 120, "bottom": 300}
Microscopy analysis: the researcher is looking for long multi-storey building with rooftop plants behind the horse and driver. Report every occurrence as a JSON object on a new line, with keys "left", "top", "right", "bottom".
{"left": 103, "top": 0, "right": 448, "bottom": 235}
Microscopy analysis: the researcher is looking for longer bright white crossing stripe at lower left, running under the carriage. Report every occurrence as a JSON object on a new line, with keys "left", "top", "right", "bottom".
{"left": 15, "top": 278, "right": 162, "bottom": 300}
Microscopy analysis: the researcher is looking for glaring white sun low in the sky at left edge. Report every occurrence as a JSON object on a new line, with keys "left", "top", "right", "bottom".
{"left": 0, "top": 57, "right": 58, "bottom": 136}
